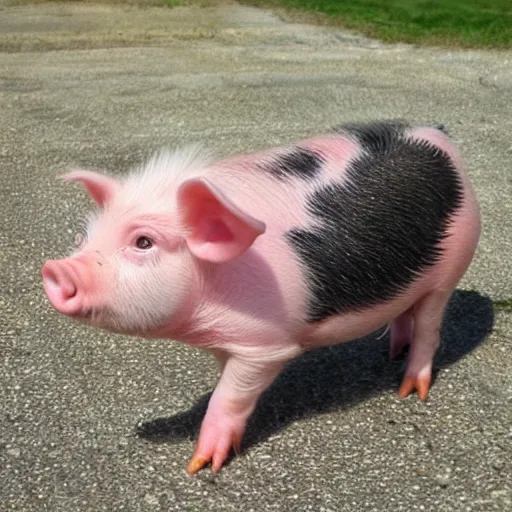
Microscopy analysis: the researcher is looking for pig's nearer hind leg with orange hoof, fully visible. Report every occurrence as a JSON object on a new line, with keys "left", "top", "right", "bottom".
{"left": 397, "top": 291, "right": 451, "bottom": 400}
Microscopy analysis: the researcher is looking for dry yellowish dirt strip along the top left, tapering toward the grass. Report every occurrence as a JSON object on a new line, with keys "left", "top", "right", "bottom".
{"left": 0, "top": 0, "right": 378, "bottom": 52}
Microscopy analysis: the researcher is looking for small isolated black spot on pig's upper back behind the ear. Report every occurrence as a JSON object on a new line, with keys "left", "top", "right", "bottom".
{"left": 259, "top": 146, "right": 323, "bottom": 180}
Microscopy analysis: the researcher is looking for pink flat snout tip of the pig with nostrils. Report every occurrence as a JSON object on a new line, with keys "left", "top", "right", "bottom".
{"left": 42, "top": 260, "right": 84, "bottom": 316}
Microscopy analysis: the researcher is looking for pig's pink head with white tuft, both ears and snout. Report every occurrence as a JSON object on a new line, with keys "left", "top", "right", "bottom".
{"left": 42, "top": 152, "right": 265, "bottom": 336}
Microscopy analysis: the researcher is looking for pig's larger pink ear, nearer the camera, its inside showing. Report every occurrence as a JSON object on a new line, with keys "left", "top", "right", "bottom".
{"left": 178, "top": 178, "right": 265, "bottom": 263}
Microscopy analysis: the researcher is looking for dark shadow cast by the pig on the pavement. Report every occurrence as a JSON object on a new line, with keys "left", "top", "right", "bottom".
{"left": 137, "top": 290, "right": 494, "bottom": 460}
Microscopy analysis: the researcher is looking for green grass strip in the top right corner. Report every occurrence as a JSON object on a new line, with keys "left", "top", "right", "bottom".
{"left": 242, "top": 0, "right": 512, "bottom": 48}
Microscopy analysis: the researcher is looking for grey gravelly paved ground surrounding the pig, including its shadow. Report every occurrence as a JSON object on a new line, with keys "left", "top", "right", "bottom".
{"left": 0, "top": 2, "right": 512, "bottom": 512}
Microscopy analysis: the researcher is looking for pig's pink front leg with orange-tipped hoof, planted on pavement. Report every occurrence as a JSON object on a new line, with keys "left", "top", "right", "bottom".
{"left": 187, "top": 353, "right": 297, "bottom": 475}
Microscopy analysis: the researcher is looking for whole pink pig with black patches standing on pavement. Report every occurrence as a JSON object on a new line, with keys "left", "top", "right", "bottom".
{"left": 42, "top": 121, "right": 480, "bottom": 474}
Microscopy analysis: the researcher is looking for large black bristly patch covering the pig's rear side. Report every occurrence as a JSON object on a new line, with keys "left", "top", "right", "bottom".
{"left": 286, "top": 124, "right": 462, "bottom": 321}
